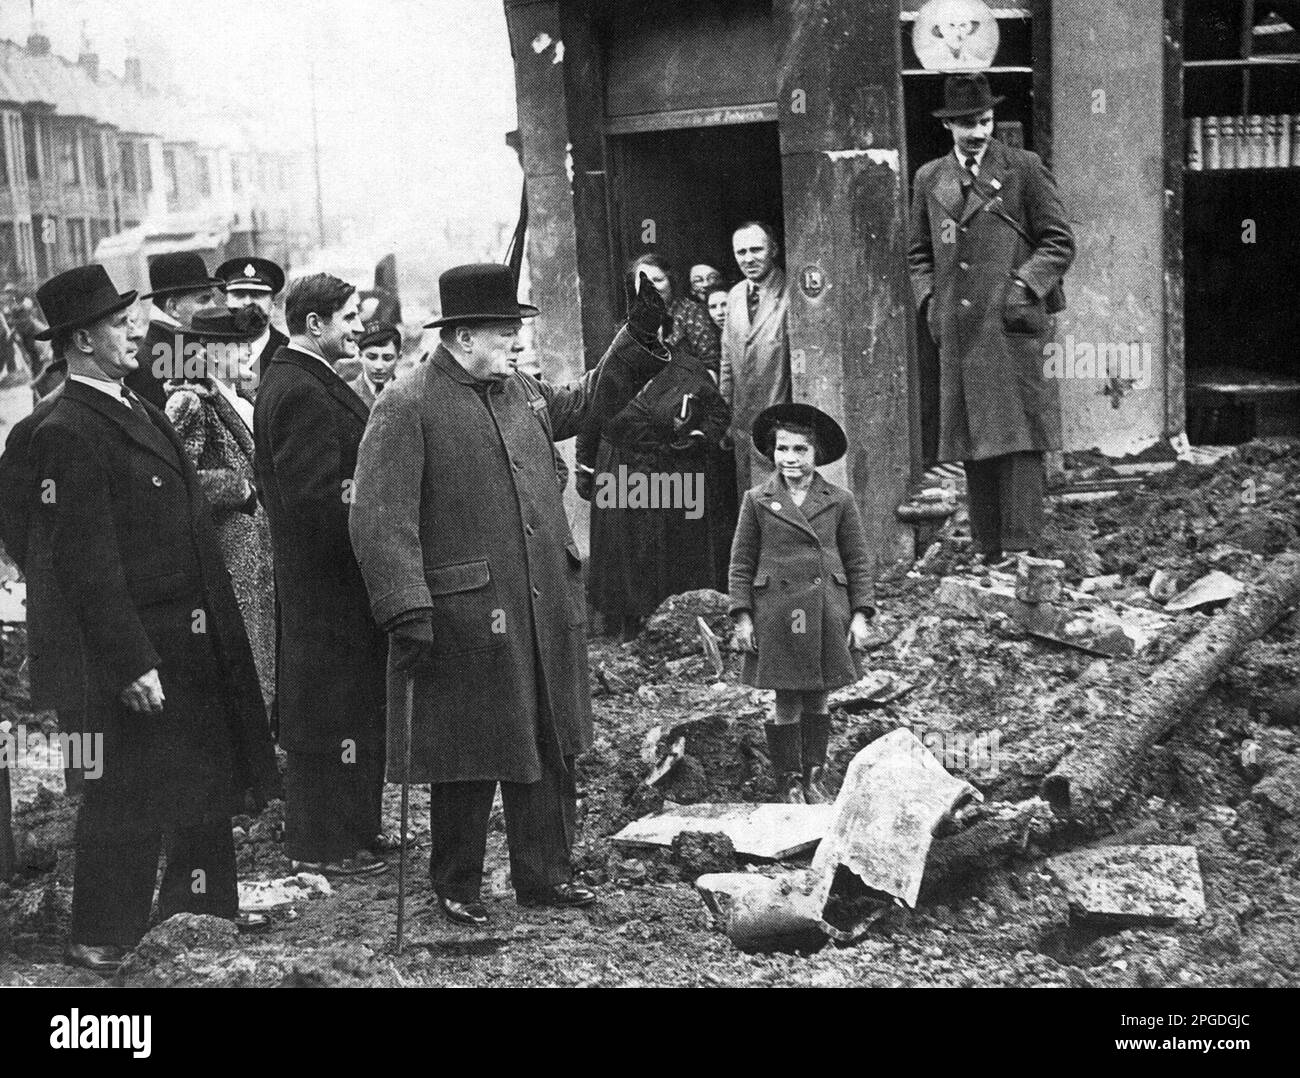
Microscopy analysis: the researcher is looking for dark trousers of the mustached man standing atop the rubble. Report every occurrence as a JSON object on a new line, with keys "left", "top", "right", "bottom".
{"left": 963, "top": 453, "right": 1044, "bottom": 554}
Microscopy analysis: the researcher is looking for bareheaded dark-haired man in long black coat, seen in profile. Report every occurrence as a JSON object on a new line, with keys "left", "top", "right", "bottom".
{"left": 252, "top": 273, "right": 387, "bottom": 876}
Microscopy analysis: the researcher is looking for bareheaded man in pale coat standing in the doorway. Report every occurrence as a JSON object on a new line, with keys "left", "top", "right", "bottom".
{"left": 718, "top": 221, "right": 792, "bottom": 497}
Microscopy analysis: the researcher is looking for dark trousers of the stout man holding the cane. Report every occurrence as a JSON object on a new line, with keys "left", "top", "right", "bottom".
{"left": 429, "top": 753, "right": 577, "bottom": 902}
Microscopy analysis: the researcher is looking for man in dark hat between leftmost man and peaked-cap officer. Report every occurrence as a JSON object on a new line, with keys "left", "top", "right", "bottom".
{"left": 126, "top": 251, "right": 221, "bottom": 411}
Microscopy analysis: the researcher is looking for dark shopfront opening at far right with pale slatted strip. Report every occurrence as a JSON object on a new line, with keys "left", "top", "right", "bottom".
{"left": 1170, "top": 0, "right": 1300, "bottom": 445}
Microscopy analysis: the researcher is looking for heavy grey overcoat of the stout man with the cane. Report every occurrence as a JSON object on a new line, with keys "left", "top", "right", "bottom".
{"left": 348, "top": 329, "right": 662, "bottom": 783}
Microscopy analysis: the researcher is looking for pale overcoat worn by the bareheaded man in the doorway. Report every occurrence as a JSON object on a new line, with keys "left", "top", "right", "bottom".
{"left": 718, "top": 267, "right": 792, "bottom": 494}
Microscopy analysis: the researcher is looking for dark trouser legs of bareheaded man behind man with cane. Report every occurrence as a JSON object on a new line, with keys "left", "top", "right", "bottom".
{"left": 285, "top": 752, "right": 384, "bottom": 862}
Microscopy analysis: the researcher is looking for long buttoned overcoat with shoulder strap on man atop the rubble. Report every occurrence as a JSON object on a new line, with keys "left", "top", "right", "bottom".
{"left": 907, "top": 139, "right": 1074, "bottom": 460}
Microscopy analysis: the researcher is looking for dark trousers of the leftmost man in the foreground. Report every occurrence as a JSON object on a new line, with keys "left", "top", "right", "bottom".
{"left": 70, "top": 804, "right": 239, "bottom": 948}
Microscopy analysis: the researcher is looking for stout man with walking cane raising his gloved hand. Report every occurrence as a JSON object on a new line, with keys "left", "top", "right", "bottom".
{"left": 351, "top": 265, "right": 667, "bottom": 925}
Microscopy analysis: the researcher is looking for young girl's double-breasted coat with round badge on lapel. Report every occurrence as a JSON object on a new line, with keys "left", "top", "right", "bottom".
{"left": 731, "top": 473, "right": 872, "bottom": 692}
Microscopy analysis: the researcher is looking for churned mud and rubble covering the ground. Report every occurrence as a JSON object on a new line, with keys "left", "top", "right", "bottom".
{"left": 0, "top": 442, "right": 1300, "bottom": 987}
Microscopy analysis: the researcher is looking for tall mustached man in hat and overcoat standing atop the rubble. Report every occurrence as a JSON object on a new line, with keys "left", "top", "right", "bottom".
{"left": 907, "top": 74, "right": 1074, "bottom": 564}
